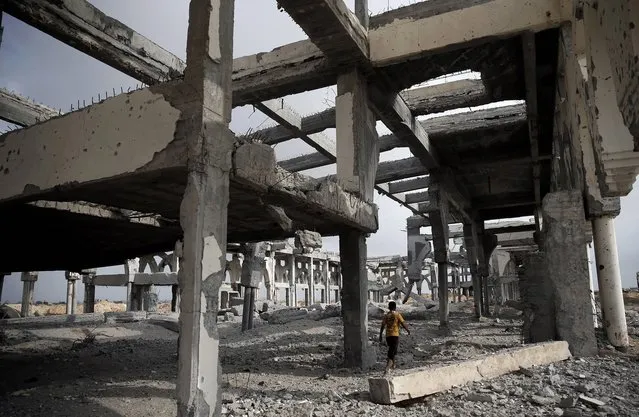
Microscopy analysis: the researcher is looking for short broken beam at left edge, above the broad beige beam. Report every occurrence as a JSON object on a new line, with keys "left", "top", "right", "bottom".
{"left": 0, "top": 88, "right": 60, "bottom": 126}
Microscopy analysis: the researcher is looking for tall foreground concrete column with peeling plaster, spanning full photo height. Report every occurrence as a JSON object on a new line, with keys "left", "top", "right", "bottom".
{"left": 177, "top": 0, "right": 235, "bottom": 417}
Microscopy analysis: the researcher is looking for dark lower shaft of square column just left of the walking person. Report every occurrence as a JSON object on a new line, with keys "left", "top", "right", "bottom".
{"left": 339, "top": 231, "right": 375, "bottom": 369}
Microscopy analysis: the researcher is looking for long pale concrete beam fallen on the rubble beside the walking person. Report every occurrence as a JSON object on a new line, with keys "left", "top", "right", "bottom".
{"left": 368, "top": 341, "right": 572, "bottom": 404}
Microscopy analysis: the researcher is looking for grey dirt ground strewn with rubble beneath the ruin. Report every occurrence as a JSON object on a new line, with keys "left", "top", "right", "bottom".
{"left": 0, "top": 303, "right": 639, "bottom": 417}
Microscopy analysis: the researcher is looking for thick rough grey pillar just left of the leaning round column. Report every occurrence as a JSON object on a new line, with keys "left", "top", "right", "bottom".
{"left": 542, "top": 191, "right": 597, "bottom": 356}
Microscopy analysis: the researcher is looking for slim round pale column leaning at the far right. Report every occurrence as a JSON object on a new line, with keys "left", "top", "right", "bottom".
{"left": 592, "top": 216, "right": 629, "bottom": 349}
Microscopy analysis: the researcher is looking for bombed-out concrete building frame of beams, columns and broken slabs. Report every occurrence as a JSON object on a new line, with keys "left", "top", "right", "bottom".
{"left": 0, "top": 0, "right": 639, "bottom": 416}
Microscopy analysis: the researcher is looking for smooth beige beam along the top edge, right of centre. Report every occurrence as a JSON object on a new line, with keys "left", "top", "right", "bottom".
{"left": 369, "top": 0, "right": 570, "bottom": 66}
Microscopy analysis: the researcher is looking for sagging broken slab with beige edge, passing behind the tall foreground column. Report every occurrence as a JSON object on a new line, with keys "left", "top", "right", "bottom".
{"left": 0, "top": 81, "right": 378, "bottom": 266}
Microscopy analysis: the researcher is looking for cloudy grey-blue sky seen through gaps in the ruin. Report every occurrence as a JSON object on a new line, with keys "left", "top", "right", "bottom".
{"left": 0, "top": 0, "right": 639, "bottom": 302}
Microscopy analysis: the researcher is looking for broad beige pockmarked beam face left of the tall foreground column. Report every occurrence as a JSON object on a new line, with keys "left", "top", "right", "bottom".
{"left": 0, "top": 85, "right": 185, "bottom": 201}
